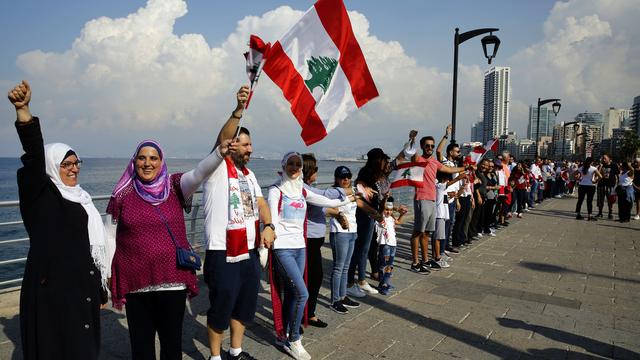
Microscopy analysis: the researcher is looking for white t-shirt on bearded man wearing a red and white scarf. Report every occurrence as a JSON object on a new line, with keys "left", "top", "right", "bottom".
{"left": 202, "top": 161, "right": 262, "bottom": 250}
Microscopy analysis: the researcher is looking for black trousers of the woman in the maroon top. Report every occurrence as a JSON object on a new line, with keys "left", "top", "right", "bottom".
{"left": 126, "top": 290, "right": 187, "bottom": 360}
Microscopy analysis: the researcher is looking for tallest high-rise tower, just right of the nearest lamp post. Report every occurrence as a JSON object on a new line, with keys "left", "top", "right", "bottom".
{"left": 482, "top": 66, "right": 511, "bottom": 143}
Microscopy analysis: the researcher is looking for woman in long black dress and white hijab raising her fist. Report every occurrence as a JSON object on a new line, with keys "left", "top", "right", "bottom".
{"left": 8, "top": 81, "right": 115, "bottom": 359}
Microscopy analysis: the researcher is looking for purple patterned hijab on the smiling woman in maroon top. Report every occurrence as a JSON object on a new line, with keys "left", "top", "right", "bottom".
{"left": 111, "top": 140, "right": 171, "bottom": 205}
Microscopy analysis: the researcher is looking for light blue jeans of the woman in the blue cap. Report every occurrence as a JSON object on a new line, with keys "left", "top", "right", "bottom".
{"left": 329, "top": 232, "right": 358, "bottom": 304}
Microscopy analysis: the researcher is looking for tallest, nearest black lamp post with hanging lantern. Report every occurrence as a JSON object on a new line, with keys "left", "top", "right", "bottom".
{"left": 451, "top": 28, "right": 500, "bottom": 144}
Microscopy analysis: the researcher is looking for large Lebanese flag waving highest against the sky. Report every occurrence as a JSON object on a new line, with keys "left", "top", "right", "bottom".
{"left": 263, "top": 0, "right": 378, "bottom": 145}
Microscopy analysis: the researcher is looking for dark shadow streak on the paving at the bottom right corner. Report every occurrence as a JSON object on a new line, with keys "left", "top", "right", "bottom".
{"left": 496, "top": 318, "right": 640, "bottom": 359}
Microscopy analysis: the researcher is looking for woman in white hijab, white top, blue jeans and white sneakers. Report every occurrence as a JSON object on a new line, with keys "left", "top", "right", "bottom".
{"left": 268, "top": 151, "right": 355, "bottom": 359}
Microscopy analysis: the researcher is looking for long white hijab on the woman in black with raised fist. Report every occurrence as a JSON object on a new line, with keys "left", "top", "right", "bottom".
{"left": 44, "top": 143, "right": 111, "bottom": 289}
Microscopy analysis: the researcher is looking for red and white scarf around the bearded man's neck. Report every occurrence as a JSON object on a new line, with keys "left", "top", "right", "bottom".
{"left": 224, "top": 157, "right": 260, "bottom": 263}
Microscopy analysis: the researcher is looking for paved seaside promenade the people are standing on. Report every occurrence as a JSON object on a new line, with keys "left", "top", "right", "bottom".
{"left": 0, "top": 198, "right": 640, "bottom": 359}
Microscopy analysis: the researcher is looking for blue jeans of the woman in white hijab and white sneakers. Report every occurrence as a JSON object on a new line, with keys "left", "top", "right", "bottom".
{"left": 273, "top": 248, "right": 309, "bottom": 341}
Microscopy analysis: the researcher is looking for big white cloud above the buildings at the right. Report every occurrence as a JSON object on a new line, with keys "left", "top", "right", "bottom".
{"left": 509, "top": 0, "right": 640, "bottom": 126}
